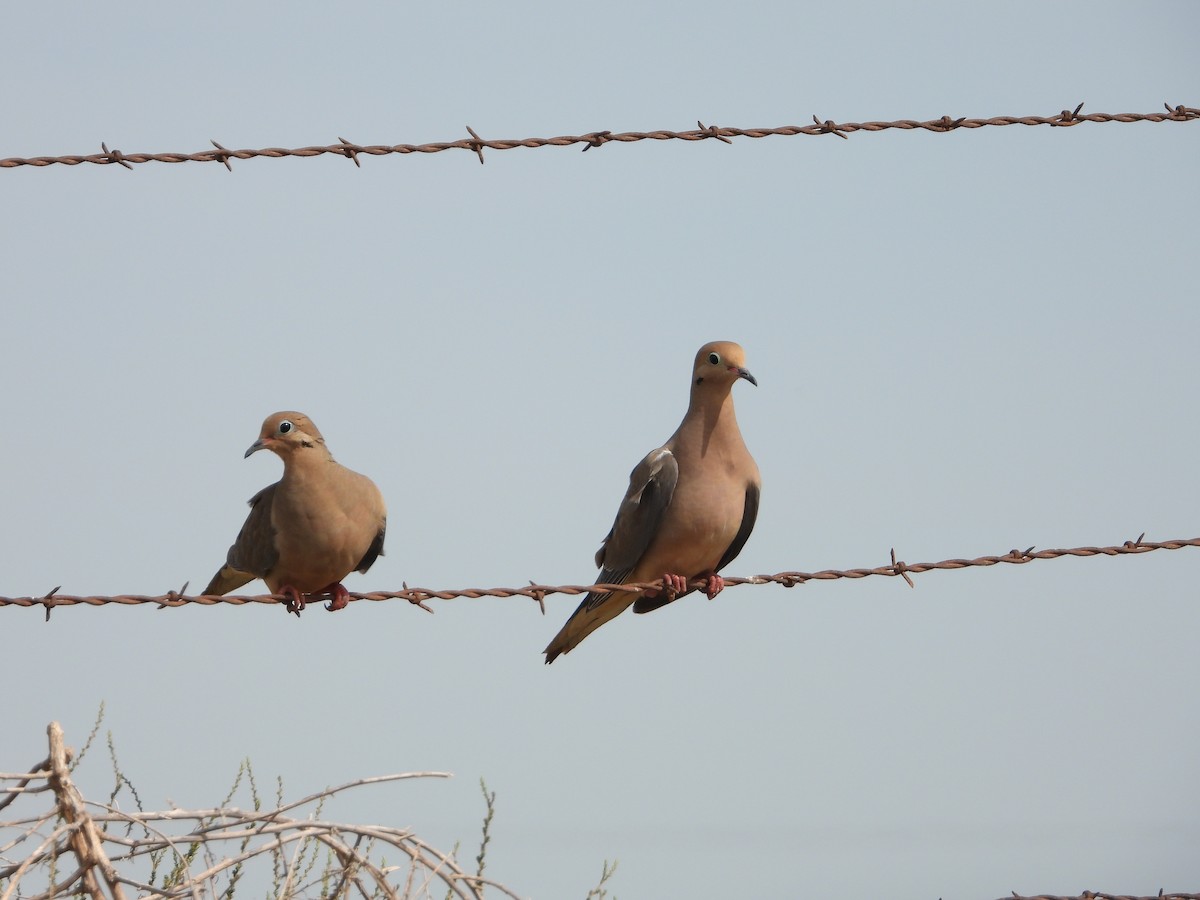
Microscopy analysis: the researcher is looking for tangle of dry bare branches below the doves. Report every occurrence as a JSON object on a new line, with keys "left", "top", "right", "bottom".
{"left": 0, "top": 722, "right": 517, "bottom": 900}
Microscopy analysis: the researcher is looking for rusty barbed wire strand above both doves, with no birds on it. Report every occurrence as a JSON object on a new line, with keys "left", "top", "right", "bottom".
{"left": 0, "top": 103, "right": 1200, "bottom": 172}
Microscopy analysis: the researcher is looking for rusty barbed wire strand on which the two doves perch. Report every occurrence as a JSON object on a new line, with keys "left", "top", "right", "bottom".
{"left": 0, "top": 533, "right": 1200, "bottom": 620}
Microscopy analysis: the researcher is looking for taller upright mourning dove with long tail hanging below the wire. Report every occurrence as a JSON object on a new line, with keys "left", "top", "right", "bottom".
{"left": 545, "top": 341, "right": 761, "bottom": 664}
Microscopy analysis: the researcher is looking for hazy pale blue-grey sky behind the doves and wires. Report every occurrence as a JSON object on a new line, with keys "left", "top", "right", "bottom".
{"left": 0, "top": 0, "right": 1200, "bottom": 900}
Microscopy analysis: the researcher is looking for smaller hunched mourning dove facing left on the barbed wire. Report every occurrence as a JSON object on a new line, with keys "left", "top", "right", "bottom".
{"left": 204, "top": 412, "right": 388, "bottom": 616}
